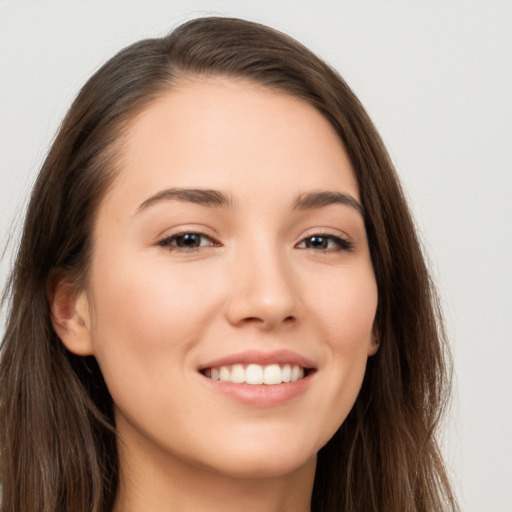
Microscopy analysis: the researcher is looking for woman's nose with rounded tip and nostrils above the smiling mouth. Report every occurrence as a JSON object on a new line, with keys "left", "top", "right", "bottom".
{"left": 226, "top": 242, "right": 300, "bottom": 330}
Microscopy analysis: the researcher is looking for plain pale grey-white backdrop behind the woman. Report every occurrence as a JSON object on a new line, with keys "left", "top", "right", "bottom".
{"left": 0, "top": 0, "right": 512, "bottom": 512}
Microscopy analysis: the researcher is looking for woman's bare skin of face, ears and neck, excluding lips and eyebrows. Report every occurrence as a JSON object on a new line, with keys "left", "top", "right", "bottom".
{"left": 53, "top": 78, "right": 377, "bottom": 512}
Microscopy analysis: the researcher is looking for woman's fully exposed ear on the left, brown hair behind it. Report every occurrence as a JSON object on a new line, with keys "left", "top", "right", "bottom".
{"left": 47, "top": 275, "right": 94, "bottom": 356}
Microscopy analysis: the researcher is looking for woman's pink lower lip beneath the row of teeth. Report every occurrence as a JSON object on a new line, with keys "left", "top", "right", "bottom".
{"left": 202, "top": 374, "right": 313, "bottom": 407}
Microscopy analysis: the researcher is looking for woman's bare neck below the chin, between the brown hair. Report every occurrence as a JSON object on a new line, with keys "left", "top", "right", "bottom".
{"left": 114, "top": 428, "right": 316, "bottom": 512}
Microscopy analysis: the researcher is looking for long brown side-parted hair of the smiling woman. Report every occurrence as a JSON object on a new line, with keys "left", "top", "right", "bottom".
{"left": 0, "top": 18, "right": 457, "bottom": 512}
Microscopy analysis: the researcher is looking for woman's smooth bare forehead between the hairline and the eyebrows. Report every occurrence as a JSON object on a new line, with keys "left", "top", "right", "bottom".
{"left": 104, "top": 77, "right": 359, "bottom": 212}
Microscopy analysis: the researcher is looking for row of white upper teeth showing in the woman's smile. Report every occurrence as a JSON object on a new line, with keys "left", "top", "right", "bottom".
{"left": 204, "top": 364, "right": 304, "bottom": 386}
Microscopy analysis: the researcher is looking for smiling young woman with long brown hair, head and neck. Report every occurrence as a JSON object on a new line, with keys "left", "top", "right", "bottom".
{"left": 0, "top": 18, "right": 457, "bottom": 512}
